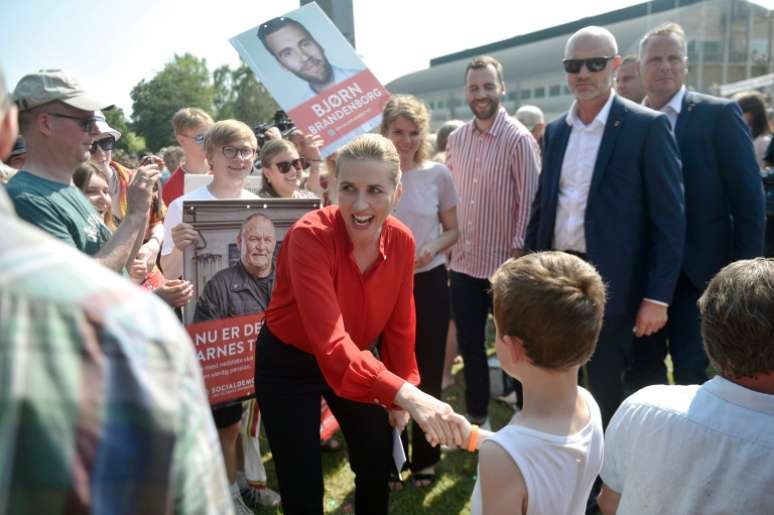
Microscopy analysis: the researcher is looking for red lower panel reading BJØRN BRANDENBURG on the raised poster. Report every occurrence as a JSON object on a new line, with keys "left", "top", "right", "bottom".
{"left": 288, "top": 70, "right": 390, "bottom": 147}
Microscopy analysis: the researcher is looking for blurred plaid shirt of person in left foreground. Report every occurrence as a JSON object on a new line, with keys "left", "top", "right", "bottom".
{"left": 0, "top": 196, "right": 233, "bottom": 515}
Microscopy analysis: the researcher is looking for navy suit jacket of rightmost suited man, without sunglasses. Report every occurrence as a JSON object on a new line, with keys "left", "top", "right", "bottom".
{"left": 675, "top": 91, "right": 766, "bottom": 290}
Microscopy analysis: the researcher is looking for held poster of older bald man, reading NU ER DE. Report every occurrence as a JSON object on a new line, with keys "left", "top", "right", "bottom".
{"left": 183, "top": 199, "right": 320, "bottom": 405}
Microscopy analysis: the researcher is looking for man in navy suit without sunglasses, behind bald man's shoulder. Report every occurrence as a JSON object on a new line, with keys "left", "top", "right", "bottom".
{"left": 630, "top": 23, "right": 765, "bottom": 388}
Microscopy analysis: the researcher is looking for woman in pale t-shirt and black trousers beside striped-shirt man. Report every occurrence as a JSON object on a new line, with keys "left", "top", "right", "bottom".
{"left": 381, "top": 95, "right": 459, "bottom": 490}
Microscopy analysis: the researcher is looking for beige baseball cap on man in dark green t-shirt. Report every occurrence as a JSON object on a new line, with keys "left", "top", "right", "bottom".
{"left": 13, "top": 70, "right": 113, "bottom": 111}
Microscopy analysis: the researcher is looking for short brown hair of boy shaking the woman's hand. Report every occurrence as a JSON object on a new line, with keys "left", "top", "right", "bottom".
{"left": 491, "top": 252, "right": 606, "bottom": 369}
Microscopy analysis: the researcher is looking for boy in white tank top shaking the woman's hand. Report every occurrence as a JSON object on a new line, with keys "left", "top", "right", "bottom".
{"left": 454, "top": 252, "right": 605, "bottom": 515}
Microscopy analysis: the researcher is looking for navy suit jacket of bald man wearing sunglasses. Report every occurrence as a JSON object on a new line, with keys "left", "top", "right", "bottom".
{"left": 525, "top": 95, "right": 685, "bottom": 316}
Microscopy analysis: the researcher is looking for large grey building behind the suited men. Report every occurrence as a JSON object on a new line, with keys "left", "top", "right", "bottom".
{"left": 387, "top": 0, "right": 774, "bottom": 128}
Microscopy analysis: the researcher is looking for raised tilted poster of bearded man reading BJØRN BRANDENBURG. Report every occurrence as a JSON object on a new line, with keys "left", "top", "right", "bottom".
{"left": 229, "top": 3, "right": 390, "bottom": 156}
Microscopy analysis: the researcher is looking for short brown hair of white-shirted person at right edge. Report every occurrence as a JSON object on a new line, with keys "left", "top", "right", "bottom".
{"left": 699, "top": 258, "right": 774, "bottom": 380}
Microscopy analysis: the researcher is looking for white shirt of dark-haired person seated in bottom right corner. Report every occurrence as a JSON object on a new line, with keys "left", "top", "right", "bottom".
{"left": 601, "top": 376, "right": 774, "bottom": 515}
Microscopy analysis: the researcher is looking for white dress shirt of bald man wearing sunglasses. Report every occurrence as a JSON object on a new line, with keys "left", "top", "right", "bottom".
{"left": 553, "top": 90, "right": 615, "bottom": 254}
